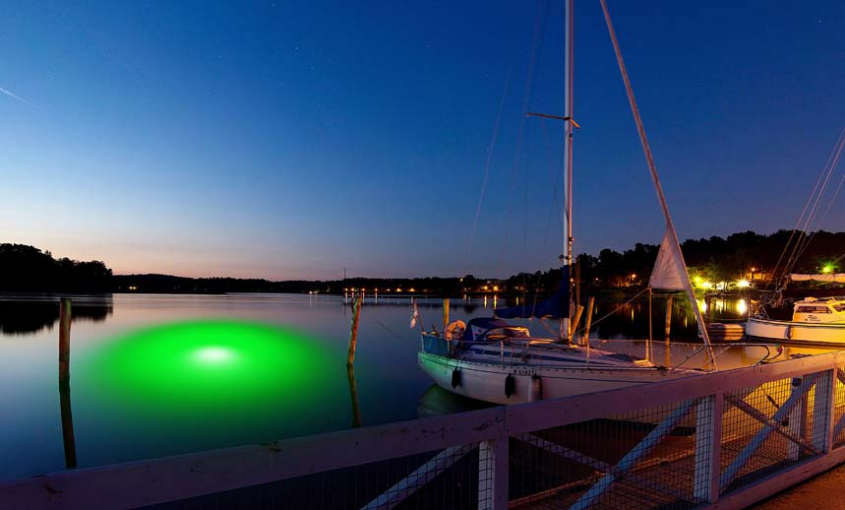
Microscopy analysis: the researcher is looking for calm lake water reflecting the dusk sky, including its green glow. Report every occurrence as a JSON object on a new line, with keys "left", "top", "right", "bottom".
{"left": 0, "top": 294, "right": 816, "bottom": 479}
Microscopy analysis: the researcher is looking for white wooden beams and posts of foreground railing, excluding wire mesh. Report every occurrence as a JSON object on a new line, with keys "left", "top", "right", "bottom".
{"left": 8, "top": 351, "right": 845, "bottom": 510}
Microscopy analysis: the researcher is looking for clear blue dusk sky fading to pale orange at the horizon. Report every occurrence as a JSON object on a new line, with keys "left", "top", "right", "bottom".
{"left": 0, "top": 0, "right": 845, "bottom": 280}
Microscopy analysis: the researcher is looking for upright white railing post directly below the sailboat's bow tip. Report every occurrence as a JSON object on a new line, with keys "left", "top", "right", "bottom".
{"left": 693, "top": 392, "right": 725, "bottom": 503}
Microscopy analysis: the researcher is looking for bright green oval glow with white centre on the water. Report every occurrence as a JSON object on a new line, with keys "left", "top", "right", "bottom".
{"left": 75, "top": 320, "right": 342, "bottom": 415}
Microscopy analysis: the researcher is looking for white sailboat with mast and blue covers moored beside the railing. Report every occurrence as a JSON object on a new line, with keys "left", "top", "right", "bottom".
{"left": 415, "top": 0, "right": 716, "bottom": 404}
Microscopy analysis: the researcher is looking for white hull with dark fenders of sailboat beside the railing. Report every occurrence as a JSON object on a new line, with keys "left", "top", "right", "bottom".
{"left": 418, "top": 352, "right": 701, "bottom": 404}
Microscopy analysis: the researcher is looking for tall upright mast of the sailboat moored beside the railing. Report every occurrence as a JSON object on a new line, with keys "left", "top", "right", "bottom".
{"left": 560, "top": 0, "right": 575, "bottom": 341}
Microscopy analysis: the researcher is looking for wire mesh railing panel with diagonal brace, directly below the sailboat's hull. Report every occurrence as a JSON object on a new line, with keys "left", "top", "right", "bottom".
{"left": 510, "top": 400, "right": 698, "bottom": 510}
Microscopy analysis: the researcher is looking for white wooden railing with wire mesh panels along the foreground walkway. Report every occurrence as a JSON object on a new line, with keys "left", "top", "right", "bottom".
{"left": 0, "top": 352, "right": 845, "bottom": 510}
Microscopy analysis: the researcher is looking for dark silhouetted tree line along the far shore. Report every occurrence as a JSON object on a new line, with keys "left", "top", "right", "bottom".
{"left": 0, "top": 230, "right": 845, "bottom": 296}
